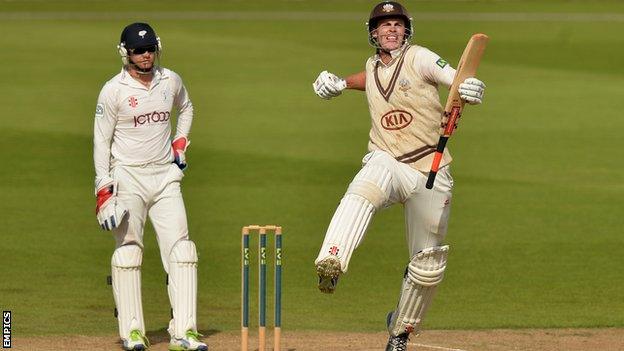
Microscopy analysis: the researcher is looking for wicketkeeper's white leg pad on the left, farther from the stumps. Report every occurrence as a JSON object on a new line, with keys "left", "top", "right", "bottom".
{"left": 111, "top": 245, "right": 145, "bottom": 339}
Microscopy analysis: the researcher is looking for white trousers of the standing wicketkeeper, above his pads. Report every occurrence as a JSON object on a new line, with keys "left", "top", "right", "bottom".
{"left": 112, "top": 163, "right": 188, "bottom": 273}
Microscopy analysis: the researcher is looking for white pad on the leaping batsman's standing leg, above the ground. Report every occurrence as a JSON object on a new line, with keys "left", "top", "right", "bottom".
{"left": 388, "top": 245, "right": 449, "bottom": 336}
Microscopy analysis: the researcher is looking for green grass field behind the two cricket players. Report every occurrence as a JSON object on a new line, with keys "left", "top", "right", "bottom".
{"left": 0, "top": 1, "right": 624, "bottom": 336}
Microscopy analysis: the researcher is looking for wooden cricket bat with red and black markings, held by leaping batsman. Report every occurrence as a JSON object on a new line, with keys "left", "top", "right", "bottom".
{"left": 426, "top": 33, "right": 490, "bottom": 189}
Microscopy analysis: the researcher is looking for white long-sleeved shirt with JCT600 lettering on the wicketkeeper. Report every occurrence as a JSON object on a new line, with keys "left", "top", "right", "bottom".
{"left": 93, "top": 67, "right": 193, "bottom": 184}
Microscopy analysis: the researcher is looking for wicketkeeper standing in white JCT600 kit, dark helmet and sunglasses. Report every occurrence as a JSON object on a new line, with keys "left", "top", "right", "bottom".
{"left": 93, "top": 23, "right": 208, "bottom": 350}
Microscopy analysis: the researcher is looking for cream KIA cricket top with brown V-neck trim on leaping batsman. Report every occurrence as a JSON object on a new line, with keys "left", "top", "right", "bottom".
{"left": 366, "top": 44, "right": 455, "bottom": 172}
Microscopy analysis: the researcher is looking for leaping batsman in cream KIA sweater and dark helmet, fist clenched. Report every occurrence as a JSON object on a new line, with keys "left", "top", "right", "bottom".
{"left": 313, "top": 1, "right": 485, "bottom": 351}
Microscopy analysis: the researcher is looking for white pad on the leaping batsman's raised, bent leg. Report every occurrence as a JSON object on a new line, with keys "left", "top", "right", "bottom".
{"left": 315, "top": 164, "right": 392, "bottom": 272}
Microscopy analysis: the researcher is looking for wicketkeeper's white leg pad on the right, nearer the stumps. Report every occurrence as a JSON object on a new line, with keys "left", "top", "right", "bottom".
{"left": 168, "top": 240, "right": 197, "bottom": 339}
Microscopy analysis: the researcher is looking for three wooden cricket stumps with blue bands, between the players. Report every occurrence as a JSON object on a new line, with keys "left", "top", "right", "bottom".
{"left": 241, "top": 225, "right": 282, "bottom": 351}
